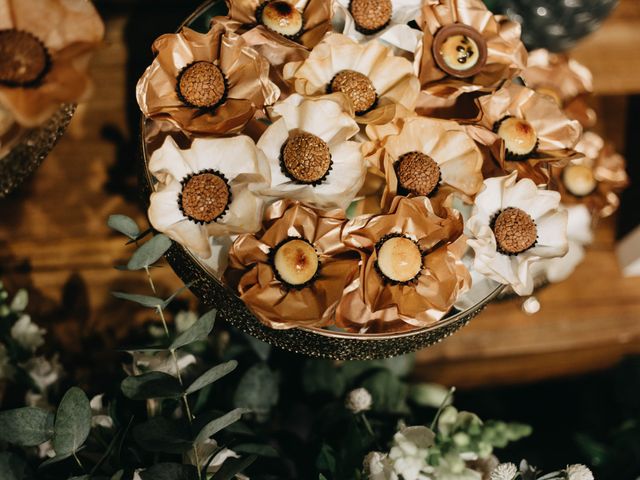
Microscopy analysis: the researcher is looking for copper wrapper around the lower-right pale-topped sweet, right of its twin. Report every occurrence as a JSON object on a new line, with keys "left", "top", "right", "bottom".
{"left": 336, "top": 197, "right": 471, "bottom": 333}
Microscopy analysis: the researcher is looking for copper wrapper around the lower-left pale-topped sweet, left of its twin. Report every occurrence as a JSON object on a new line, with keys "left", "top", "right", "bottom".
{"left": 228, "top": 200, "right": 360, "bottom": 329}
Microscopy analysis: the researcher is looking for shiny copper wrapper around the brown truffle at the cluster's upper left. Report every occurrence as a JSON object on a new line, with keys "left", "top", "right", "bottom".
{"left": 136, "top": 25, "right": 280, "bottom": 134}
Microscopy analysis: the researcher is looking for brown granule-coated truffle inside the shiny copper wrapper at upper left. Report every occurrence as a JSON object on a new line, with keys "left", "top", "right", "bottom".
{"left": 178, "top": 61, "right": 227, "bottom": 108}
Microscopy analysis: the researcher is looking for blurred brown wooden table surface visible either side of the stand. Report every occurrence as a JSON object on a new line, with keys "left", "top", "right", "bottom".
{"left": 0, "top": 0, "right": 640, "bottom": 387}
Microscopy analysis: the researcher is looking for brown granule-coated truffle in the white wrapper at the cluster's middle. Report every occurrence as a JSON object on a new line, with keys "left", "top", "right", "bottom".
{"left": 280, "top": 131, "right": 331, "bottom": 185}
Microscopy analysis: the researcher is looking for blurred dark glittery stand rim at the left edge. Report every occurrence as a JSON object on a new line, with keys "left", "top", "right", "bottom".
{"left": 0, "top": 104, "right": 76, "bottom": 198}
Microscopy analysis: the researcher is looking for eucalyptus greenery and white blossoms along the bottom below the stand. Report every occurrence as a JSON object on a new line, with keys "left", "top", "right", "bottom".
{"left": 0, "top": 232, "right": 593, "bottom": 480}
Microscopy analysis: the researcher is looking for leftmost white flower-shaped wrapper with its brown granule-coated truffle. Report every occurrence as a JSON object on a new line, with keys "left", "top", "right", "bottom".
{"left": 148, "top": 135, "right": 270, "bottom": 258}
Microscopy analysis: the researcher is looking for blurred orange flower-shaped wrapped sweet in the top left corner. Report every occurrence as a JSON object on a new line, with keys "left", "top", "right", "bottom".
{"left": 0, "top": 0, "right": 104, "bottom": 158}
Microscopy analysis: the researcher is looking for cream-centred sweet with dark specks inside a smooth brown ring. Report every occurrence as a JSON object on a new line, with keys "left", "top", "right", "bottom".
{"left": 433, "top": 23, "right": 487, "bottom": 78}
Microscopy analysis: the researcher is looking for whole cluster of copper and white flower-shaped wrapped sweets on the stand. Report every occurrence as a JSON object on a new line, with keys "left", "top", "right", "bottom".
{"left": 137, "top": 0, "right": 627, "bottom": 334}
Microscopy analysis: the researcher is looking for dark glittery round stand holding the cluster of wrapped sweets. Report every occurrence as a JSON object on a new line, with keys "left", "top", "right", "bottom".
{"left": 140, "top": 0, "right": 502, "bottom": 360}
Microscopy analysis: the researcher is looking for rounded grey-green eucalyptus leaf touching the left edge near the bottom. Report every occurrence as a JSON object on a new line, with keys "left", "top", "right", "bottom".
{"left": 0, "top": 407, "right": 54, "bottom": 447}
